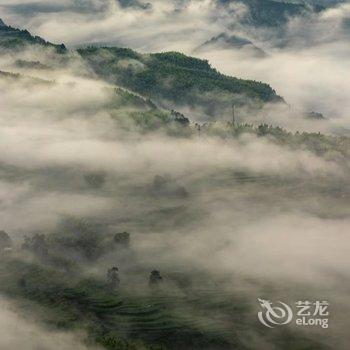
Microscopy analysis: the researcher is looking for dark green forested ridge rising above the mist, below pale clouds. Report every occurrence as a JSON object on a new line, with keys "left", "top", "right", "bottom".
{"left": 78, "top": 47, "right": 283, "bottom": 116}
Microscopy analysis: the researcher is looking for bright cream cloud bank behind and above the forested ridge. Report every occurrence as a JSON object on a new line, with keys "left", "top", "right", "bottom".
{"left": 0, "top": 0, "right": 350, "bottom": 133}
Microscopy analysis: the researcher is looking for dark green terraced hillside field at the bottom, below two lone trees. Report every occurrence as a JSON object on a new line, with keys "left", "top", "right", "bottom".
{"left": 0, "top": 257, "right": 330, "bottom": 350}
